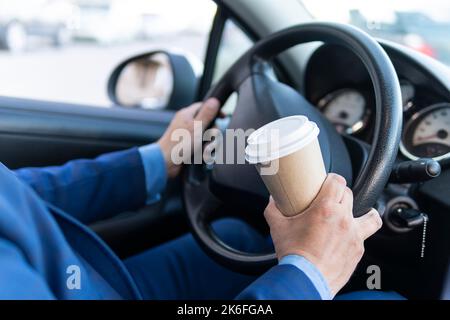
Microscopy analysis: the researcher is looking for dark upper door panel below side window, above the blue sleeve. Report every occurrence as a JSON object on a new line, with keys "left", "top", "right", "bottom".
{"left": 0, "top": 97, "right": 173, "bottom": 168}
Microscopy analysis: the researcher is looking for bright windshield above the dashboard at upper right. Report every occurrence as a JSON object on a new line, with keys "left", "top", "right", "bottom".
{"left": 302, "top": 0, "right": 450, "bottom": 65}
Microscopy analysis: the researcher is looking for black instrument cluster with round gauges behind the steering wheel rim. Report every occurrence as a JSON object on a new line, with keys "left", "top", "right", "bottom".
{"left": 305, "top": 44, "right": 450, "bottom": 162}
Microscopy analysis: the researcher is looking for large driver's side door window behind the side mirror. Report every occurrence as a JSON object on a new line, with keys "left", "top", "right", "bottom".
{"left": 0, "top": 0, "right": 216, "bottom": 106}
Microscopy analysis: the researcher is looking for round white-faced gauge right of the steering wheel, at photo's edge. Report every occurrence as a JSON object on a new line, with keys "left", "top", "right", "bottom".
{"left": 400, "top": 103, "right": 450, "bottom": 160}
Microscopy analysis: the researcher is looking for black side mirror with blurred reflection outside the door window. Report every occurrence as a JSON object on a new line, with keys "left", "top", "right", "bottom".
{"left": 107, "top": 51, "right": 198, "bottom": 110}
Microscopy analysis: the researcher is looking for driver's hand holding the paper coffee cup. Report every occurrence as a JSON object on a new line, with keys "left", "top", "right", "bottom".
{"left": 264, "top": 174, "right": 382, "bottom": 296}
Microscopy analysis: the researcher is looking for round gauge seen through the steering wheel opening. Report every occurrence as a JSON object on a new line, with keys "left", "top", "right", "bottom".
{"left": 318, "top": 89, "right": 368, "bottom": 134}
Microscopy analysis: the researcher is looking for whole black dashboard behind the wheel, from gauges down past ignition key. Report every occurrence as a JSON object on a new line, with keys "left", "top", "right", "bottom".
{"left": 301, "top": 41, "right": 450, "bottom": 298}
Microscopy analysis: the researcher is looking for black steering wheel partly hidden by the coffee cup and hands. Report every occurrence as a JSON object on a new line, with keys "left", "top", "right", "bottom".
{"left": 183, "top": 23, "right": 402, "bottom": 273}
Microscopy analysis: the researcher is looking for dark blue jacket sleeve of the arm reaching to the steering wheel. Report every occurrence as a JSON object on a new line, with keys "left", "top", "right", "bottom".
{"left": 15, "top": 148, "right": 148, "bottom": 223}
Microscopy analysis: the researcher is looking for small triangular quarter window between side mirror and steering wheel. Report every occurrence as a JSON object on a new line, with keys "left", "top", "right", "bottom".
{"left": 212, "top": 19, "right": 254, "bottom": 114}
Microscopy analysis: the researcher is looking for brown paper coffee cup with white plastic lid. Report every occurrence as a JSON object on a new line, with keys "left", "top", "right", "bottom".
{"left": 245, "top": 116, "right": 326, "bottom": 216}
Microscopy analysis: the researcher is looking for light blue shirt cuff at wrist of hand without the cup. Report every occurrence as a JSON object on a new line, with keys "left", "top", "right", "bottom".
{"left": 139, "top": 143, "right": 167, "bottom": 204}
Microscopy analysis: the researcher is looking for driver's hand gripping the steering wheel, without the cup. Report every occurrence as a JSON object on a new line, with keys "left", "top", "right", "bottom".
{"left": 158, "top": 98, "right": 220, "bottom": 178}
